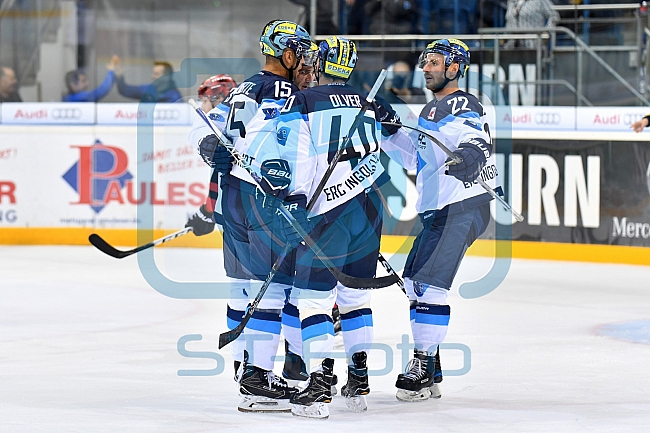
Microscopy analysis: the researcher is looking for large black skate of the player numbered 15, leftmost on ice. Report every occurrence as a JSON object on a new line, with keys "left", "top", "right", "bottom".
{"left": 237, "top": 352, "right": 298, "bottom": 412}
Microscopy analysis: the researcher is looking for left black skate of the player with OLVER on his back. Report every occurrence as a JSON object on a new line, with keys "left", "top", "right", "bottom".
{"left": 291, "top": 358, "right": 334, "bottom": 419}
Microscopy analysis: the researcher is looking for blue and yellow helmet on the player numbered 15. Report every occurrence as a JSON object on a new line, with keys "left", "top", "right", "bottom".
{"left": 260, "top": 20, "right": 312, "bottom": 58}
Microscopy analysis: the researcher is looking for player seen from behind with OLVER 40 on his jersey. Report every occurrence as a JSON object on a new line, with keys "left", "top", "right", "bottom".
{"left": 256, "top": 36, "right": 397, "bottom": 418}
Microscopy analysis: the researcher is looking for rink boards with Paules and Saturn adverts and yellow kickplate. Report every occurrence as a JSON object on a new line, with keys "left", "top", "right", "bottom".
{"left": 0, "top": 104, "right": 650, "bottom": 264}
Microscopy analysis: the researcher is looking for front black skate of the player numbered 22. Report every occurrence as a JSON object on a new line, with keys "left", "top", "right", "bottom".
{"left": 395, "top": 349, "right": 437, "bottom": 402}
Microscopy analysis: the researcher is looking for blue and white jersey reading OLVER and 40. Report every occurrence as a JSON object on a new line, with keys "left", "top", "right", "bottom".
{"left": 265, "top": 84, "right": 384, "bottom": 215}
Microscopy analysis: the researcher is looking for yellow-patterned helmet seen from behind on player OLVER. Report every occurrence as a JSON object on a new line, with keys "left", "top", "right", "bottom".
{"left": 318, "top": 36, "right": 357, "bottom": 81}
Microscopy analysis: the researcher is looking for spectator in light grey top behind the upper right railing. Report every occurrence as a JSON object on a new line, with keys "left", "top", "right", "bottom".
{"left": 505, "top": 0, "right": 560, "bottom": 49}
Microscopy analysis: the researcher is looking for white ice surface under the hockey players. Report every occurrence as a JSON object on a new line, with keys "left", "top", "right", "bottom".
{"left": 0, "top": 246, "right": 650, "bottom": 433}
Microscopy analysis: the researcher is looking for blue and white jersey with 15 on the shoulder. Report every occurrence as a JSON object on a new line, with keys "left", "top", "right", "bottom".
{"left": 189, "top": 71, "right": 298, "bottom": 184}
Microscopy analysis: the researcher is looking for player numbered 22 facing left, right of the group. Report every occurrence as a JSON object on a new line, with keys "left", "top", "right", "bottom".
{"left": 384, "top": 39, "right": 501, "bottom": 402}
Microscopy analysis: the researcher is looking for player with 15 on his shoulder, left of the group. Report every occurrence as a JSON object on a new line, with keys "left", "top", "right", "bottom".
{"left": 188, "top": 20, "right": 313, "bottom": 411}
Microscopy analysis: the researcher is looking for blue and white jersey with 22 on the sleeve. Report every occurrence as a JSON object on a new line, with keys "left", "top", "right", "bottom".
{"left": 383, "top": 90, "right": 500, "bottom": 214}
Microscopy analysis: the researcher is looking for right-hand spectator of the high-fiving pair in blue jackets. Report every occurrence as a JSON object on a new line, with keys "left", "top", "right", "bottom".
{"left": 115, "top": 59, "right": 183, "bottom": 102}
